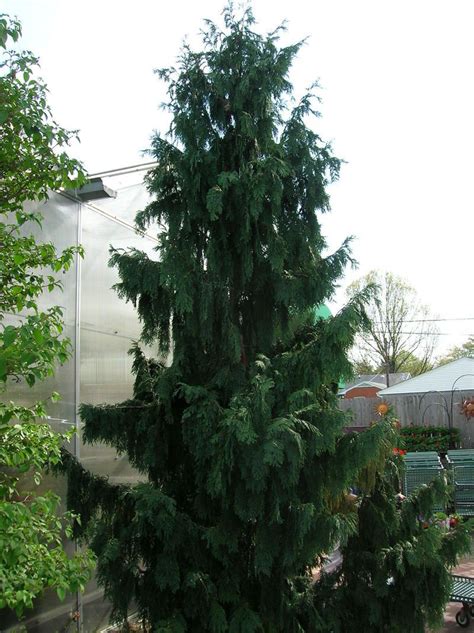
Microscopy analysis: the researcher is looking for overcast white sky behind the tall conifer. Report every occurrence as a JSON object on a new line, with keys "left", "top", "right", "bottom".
{"left": 2, "top": 0, "right": 474, "bottom": 352}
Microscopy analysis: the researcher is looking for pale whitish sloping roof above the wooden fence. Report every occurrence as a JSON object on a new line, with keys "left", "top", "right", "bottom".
{"left": 378, "top": 358, "right": 474, "bottom": 398}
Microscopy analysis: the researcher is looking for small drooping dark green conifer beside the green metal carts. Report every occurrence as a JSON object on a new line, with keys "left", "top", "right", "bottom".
{"left": 315, "top": 418, "right": 472, "bottom": 633}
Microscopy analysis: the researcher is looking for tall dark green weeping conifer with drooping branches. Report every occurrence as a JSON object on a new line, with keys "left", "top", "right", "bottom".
{"left": 63, "top": 7, "right": 391, "bottom": 633}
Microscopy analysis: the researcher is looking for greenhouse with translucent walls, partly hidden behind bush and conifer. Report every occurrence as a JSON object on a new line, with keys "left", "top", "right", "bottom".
{"left": 0, "top": 164, "right": 156, "bottom": 632}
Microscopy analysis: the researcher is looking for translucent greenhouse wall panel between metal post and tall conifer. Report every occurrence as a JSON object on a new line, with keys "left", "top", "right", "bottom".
{"left": 80, "top": 202, "right": 152, "bottom": 483}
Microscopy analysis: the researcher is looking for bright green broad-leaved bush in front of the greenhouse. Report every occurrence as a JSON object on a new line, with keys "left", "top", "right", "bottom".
{"left": 0, "top": 14, "right": 93, "bottom": 616}
